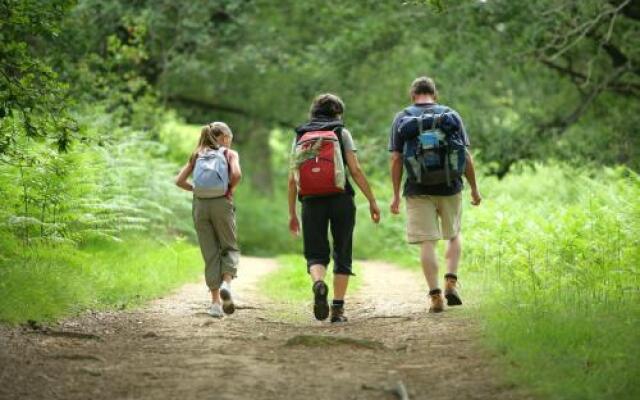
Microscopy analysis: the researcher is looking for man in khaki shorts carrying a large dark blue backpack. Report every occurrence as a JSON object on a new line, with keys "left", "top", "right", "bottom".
{"left": 389, "top": 77, "right": 482, "bottom": 312}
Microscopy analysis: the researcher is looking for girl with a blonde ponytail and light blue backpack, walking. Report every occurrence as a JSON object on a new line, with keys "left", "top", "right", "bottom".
{"left": 176, "top": 122, "right": 242, "bottom": 318}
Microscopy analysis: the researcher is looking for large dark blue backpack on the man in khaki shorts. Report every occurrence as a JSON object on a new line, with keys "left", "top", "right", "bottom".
{"left": 398, "top": 105, "right": 466, "bottom": 186}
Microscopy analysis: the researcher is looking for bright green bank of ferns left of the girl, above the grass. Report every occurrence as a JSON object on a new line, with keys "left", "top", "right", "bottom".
{"left": 0, "top": 128, "right": 192, "bottom": 245}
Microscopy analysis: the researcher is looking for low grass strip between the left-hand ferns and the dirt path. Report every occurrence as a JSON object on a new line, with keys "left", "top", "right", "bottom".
{"left": 0, "top": 236, "right": 202, "bottom": 324}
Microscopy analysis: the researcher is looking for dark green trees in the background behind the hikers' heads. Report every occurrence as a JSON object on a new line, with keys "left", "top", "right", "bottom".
{"left": 62, "top": 0, "right": 640, "bottom": 178}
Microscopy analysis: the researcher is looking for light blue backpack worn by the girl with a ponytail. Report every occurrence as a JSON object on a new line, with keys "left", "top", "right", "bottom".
{"left": 193, "top": 147, "right": 229, "bottom": 199}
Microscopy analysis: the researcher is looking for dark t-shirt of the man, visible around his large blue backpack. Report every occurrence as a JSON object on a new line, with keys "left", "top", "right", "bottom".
{"left": 389, "top": 103, "right": 470, "bottom": 196}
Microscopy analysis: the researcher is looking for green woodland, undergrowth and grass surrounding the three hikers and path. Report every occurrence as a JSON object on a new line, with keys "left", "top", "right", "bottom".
{"left": 0, "top": 0, "right": 640, "bottom": 398}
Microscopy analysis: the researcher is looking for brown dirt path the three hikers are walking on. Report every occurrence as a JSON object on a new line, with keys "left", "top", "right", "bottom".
{"left": 0, "top": 257, "right": 527, "bottom": 400}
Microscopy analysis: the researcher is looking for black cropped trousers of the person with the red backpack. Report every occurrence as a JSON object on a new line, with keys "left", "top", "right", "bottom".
{"left": 302, "top": 194, "right": 356, "bottom": 275}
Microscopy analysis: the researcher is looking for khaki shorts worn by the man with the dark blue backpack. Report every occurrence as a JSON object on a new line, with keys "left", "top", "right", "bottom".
{"left": 406, "top": 193, "right": 462, "bottom": 244}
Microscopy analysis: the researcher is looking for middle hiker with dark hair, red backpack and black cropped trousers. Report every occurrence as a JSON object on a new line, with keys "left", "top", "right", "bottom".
{"left": 289, "top": 94, "right": 380, "bottom": 323}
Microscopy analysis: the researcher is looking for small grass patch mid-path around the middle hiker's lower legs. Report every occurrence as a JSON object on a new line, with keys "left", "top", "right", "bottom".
{"left": 259, "top": 254, "right": 361, "bottom": 303}
